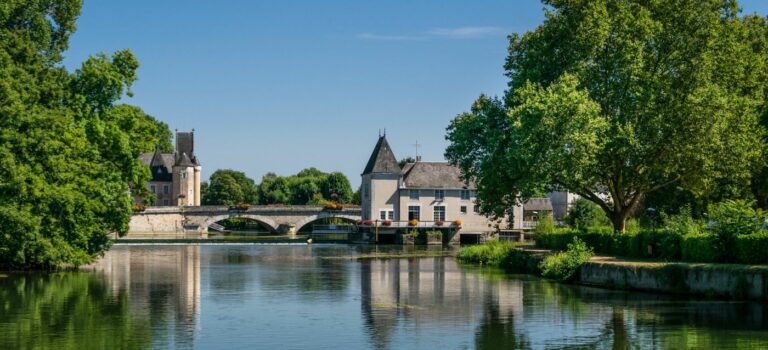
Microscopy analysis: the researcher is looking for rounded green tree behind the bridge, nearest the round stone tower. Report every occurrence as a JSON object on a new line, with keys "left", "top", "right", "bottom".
{"left": 201, "top": 169, "right": 259, "bottom": 205}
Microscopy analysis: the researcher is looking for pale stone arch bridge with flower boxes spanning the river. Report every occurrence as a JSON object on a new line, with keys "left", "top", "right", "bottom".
{"left": 128, "top": 205, "right": 361, "bottom": 234}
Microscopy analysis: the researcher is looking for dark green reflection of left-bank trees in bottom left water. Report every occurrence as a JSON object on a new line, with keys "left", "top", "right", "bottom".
{"left": 0, "top": 272, "right": 152, "bottom": 350}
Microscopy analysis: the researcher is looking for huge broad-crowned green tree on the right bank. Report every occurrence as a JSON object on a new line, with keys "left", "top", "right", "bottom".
{"left": 446, "top": 0, "right": 768, "bottom": 231}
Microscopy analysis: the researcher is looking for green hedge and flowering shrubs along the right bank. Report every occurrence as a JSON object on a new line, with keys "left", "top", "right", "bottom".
{"left": 536, "top": 201, "right": 768, "bottom": 264}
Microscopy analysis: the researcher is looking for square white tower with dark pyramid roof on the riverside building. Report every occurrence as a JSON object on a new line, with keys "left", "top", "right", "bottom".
{"left": 361, "top": 134, "right": 400, "bottom": 220}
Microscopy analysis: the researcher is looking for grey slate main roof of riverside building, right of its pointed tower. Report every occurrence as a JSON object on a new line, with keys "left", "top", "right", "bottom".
{"left": 402, "top": 162, "right": 474, "bottom": 189}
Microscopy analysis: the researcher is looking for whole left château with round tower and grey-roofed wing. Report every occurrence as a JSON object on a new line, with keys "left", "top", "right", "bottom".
{"left": 134, "top": 130, "right": 202, "bottom": 206}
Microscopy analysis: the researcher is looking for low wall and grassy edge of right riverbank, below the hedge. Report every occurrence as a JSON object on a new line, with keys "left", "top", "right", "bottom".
{"left": 457, "top": 243, "right": 768, "bottom": 302}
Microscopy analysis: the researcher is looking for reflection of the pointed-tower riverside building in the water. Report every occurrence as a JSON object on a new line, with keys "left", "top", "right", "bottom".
{"left": 360, "top": 257, "right": 523, "bottom": 348}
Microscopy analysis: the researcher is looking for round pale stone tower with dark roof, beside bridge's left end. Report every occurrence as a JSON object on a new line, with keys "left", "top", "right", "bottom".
{"left": 173, "top": 133, "right": 202, "bottom": 206}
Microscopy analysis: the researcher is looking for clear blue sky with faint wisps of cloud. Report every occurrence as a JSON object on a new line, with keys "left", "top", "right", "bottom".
{"left": 64, "top": 0, "right": 768, "bottom": 187}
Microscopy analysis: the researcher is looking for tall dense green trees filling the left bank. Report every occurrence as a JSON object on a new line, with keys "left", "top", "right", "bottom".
{"left": 0, "top": 0, "right": 170, "bottom": 268}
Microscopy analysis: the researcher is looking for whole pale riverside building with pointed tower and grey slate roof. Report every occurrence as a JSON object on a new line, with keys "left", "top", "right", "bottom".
{"left": 361, "top": 135, "right": 523, "bottom": 233}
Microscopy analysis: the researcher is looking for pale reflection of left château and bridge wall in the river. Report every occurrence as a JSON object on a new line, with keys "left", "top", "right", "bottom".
{"left": 91, "top": 245, "right": 200, "bottom": 346}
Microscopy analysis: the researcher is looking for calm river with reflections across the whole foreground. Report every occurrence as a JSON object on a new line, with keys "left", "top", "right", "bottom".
{"left": 0, "top": 245, "right": 768, "bottom": 350}
